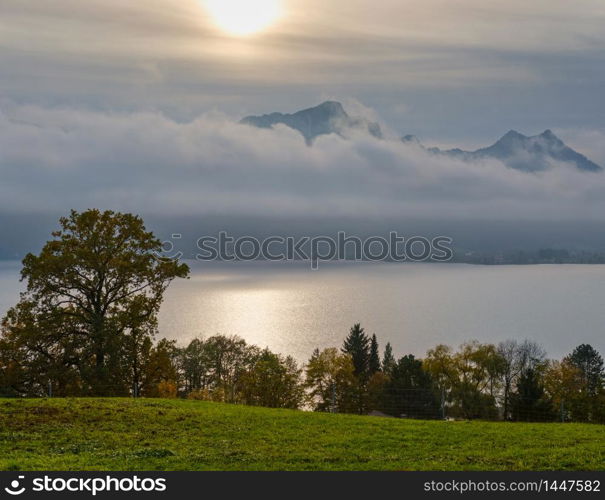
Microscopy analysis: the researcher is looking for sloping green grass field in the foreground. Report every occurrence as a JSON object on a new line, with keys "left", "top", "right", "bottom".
{"left": 0, "top": 399, "right": 605, "bottom": 471}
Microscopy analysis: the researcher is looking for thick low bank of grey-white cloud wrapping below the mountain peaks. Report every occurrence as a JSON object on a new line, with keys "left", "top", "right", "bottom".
{"left": 0, "top": 103, "right": 605, "bottom": 221}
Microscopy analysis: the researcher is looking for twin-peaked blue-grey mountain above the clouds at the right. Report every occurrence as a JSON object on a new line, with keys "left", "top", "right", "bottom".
{"left": 422, "top": 130, "right": 603, "bottom": 172}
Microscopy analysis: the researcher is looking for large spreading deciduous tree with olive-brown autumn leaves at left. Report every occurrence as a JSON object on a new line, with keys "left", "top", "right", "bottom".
{"left": 0, "top": 209, "right": 189, "bottom": 395}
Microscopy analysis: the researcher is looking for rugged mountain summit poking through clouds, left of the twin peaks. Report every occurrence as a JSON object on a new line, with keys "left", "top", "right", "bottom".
{"left": 240, "top": 101, "right": 382, "bottom": 145}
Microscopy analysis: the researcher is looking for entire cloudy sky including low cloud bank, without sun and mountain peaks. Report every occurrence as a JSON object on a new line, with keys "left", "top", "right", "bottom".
{"left": 0, "top": 0, "right": 605, "bottom": 246}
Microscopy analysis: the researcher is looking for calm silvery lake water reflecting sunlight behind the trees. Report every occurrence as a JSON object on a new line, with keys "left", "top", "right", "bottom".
{"left": 0, "top": 263, "right": 605, "bottom": 360}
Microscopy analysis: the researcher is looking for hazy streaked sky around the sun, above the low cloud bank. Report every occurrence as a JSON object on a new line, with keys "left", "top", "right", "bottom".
{"left": 0, "top": 0, "right": 605, "bottom": 147}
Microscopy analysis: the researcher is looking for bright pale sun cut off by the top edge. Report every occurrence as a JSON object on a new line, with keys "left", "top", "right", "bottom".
{"left": 203, "top": 0, "right": 282, "bottom": 36}
